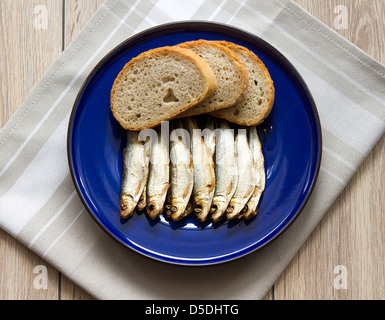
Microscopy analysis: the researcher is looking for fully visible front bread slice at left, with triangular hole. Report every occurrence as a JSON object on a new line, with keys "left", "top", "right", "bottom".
{"left": 111, "top": 46, "right": 216, "bottom": 131}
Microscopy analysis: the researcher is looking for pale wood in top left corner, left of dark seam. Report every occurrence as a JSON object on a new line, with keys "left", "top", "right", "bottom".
{"left": 0, "top": 0, "right": 62, "bottom": 127}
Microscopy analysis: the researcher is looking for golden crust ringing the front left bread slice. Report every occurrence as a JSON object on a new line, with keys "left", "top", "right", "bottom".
{"left": 110, "top": 46, "right": 217, "bottom": 131}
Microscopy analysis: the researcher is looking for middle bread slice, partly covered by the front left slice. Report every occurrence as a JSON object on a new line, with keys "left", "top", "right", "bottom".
{"left": 178, "top": 40, "right": 248, "bottom": 117}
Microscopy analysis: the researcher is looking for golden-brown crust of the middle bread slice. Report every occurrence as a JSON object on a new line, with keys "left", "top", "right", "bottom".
{"left": 176, "top": 39, "right": 248, "bottom": 117}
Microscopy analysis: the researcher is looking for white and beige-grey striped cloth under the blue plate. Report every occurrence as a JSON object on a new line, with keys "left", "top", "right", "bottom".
{"left": 0, "top": 0, "right": 385, "bottom": 299}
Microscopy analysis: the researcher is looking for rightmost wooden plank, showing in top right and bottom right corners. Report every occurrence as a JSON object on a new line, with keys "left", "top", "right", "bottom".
{"left": 274, "top": 0, "right": 385, "bottom": 299}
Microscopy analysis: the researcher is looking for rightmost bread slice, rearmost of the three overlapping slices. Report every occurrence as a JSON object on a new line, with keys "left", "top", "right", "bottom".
{"left": 212, "top": 41, "right": 275, "bottom": 126}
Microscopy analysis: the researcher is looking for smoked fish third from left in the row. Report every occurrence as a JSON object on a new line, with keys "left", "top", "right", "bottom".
{"left": 166, "top": 121, "right": 194, "bottom": 221}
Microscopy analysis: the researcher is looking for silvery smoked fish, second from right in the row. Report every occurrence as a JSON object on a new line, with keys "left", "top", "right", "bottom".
{"left": 226, "top": 129, "right": 255, "bottom": 220}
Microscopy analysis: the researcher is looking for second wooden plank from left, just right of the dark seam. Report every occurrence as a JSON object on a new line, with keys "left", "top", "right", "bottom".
{"left": 61, "top": 0, "right": 103, "bottom": 300}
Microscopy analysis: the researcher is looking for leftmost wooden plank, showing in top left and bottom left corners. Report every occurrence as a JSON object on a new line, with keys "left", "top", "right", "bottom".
{"left": 0, "top": 0, "right": 62, "bottom": 300}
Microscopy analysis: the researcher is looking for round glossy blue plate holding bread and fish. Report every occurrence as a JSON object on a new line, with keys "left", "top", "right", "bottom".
{"left": 68, "top": 21, "right": 322, "bottom": 265}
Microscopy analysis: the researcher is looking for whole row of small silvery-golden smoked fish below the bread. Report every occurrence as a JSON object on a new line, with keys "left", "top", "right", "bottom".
{"left": 120, "top": 117, "right": 265, "bottom": 222}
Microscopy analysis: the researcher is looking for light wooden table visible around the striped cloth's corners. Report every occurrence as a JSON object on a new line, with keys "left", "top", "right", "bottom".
{"left": 0, "top": 0, "right": 385, "bottom": 300}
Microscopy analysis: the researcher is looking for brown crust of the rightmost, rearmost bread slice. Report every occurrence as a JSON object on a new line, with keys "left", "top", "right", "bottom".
{"left": 212, "top": 41, "right": 275, "bottom": 126}
